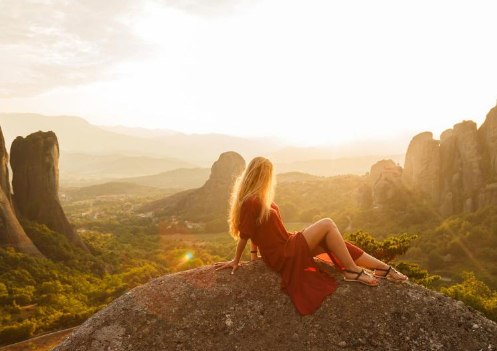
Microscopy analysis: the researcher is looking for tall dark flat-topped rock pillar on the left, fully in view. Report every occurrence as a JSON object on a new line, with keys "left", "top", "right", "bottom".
{"left": 10, "top": 131, "right": 86, "bottom": 249}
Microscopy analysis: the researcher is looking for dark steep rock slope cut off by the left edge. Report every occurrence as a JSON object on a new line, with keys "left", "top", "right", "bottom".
{"left": 0, "top": 128, "right": 41, "bottom": 255}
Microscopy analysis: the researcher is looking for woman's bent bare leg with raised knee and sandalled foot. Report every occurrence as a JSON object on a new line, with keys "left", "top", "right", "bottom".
{"left": 302, "top": 218, "right": 378, "bottom": 285}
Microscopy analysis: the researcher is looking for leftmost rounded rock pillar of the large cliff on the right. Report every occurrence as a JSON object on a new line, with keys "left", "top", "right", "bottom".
{"left": 402, "top": 132, "right": 440, "bottom": 204}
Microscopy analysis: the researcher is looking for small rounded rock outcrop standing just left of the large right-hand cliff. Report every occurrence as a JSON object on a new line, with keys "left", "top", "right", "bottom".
{"left": 369, "top": 160, "right": 404, "bottom": 207}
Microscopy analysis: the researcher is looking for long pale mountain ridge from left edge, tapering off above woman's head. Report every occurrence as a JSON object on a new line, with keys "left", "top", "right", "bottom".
{"left": 0, "top": 113, "right": 282, "bottom": 166}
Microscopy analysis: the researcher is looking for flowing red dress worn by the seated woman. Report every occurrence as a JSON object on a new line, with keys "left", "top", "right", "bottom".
{"left": 239, "top": 197, "right": 364, "bottom": 315}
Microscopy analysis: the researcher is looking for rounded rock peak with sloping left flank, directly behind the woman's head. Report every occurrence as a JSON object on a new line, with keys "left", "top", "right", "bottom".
{"left": 142, "top": 151, "right": 245, "bottom": 221}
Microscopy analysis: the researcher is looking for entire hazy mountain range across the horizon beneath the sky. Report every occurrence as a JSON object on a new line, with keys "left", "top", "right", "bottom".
{"left": 0, "top": 113, "right": 405, "bottom": 186}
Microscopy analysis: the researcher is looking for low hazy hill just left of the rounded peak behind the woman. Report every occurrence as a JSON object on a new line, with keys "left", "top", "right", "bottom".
{"left": 118, "top": 168, "right": 210, "bottom": 189}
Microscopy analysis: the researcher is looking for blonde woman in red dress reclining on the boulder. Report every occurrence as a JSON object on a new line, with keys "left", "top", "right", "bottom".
{"left": 216, "top": 157, "right": 408, "bottom": 315}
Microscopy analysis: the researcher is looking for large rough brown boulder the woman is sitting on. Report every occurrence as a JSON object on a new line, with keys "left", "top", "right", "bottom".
{"left": 55, "top": 261, "right": 497, "bottom": 351}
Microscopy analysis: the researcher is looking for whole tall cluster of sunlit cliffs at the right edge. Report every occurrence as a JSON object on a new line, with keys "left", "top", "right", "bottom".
{"left": 403, "top": 103, "right": 497, "bottom": 217}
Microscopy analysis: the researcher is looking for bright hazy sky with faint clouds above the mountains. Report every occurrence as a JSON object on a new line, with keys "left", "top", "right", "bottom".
{"left": 0, "top": 0, "right": 497, "bottom": 145}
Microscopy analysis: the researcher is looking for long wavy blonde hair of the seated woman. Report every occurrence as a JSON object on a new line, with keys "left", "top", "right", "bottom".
{"left": 228, "top": 157, "right": 276, "bottom": 239}
